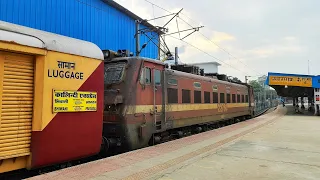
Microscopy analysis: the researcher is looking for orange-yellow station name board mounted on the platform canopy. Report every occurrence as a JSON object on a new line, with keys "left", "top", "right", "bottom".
{"left": 269, "top": 76, "right": 312, "bottom": 87}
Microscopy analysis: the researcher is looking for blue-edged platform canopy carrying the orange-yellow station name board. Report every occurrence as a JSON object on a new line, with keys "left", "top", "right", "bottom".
{"left": 266, "top": 72, "right": 320, "bottom": 97}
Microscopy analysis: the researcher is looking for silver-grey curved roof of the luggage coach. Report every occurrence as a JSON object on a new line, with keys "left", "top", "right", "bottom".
{"left": 0, "top": 21, "right": 104, "bottom": 60}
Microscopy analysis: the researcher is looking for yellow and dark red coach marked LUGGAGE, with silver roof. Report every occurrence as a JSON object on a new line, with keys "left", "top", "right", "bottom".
{"left": 0, "top": 21, "right": 104, "bottom": 173}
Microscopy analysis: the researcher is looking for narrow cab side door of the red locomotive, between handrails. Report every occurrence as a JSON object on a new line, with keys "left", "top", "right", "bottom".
{"left": 153, "top": 64, "right": 165, "bottom": 131}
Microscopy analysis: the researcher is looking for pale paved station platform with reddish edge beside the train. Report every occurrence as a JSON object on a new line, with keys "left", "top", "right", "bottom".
{"left": 29, "top": 105, "right": 320, "bottom": 180}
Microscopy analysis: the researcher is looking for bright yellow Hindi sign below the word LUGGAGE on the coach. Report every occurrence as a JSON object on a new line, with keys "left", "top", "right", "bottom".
{"left": 53, "top": 90, "right": 97, "bottom": 113}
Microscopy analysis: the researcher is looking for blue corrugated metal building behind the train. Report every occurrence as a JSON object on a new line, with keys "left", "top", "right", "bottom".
{"left": 0, "top": 0, "right": 159, "bottom": 59}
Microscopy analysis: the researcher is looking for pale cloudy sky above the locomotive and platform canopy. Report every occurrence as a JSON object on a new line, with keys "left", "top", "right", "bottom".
{"left": 116, "top": 0, "right": 320, "bottom": 80}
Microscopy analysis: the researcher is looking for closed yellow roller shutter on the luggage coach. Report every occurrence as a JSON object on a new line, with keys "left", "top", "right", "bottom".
{"left": 0, "top": 52, "right": 34, "bottom": 160}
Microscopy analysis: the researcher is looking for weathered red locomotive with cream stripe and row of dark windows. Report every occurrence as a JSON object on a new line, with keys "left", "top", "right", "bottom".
{"left": 103, "top": 57, "right": 254, "bottom": 150}
